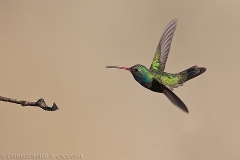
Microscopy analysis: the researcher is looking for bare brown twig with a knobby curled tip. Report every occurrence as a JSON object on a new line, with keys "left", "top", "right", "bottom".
{"left": 0, "top": 96, "right": 58, "bottom": 111}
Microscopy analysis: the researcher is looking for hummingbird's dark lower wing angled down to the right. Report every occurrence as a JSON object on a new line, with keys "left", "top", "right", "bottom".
{"left": 152, "top": 79, "right": 188, "bottom": 113}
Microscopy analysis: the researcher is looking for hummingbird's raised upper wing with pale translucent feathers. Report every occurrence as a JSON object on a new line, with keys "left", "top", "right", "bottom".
{"left": 150, "top": 19, "right": 177, "bottom": 71}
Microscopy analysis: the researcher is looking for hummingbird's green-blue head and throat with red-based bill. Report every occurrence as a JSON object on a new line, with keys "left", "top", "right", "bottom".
{"left": 106, "top": 64, "right": 150, "bottom": 88}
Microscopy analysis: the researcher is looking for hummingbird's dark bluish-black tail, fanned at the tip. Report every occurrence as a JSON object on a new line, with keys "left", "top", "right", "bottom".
{"left": 179, "top": 66, "right": 207, "bottom": 81}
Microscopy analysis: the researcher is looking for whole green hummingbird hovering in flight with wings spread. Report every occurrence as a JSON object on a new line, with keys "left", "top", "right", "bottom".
{"left": 106, "top": 19, "right": 206, "bottom": 113}
